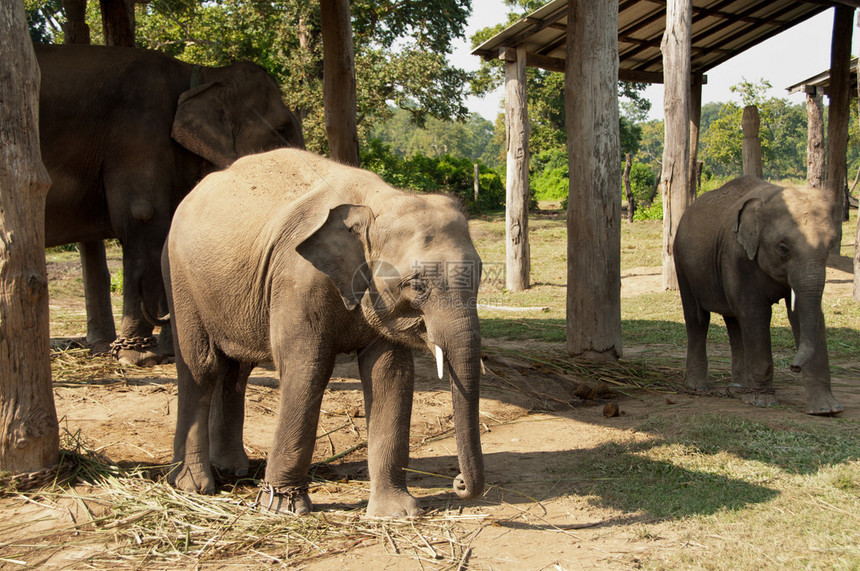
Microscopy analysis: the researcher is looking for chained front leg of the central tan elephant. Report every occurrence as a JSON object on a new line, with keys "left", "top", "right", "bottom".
{"left": 262, "top": 346, "right": 335, "bottom": 515}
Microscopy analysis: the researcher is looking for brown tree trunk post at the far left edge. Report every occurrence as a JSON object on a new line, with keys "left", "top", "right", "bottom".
{"left": 0, "top": 0, "right": 59, "bottom": 473}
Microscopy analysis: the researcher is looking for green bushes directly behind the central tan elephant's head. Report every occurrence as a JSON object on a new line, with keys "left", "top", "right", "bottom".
{"left": 361, "top": 139, "right": 505, "bottom": 213}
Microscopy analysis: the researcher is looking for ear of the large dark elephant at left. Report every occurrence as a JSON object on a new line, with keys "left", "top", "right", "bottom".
{"left": 170, "top": 83, "right": 238, "bottom": 169}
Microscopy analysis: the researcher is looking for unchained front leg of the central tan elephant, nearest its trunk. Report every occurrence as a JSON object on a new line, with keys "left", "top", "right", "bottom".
{"left": 358, "top": 341, "right": 421, "bottom": 517}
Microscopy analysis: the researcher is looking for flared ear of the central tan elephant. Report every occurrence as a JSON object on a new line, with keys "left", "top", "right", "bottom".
{"left": 296, "top": 204, "right": 374, "bottom": 310}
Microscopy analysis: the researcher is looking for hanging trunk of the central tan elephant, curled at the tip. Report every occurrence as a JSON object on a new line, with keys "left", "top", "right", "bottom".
{"left": 428, "top": 308, "right": 484, "bottom": 500}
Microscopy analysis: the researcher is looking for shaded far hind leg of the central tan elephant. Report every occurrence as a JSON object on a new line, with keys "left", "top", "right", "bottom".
{"left": 209, "top": 357, "right": 254, "bottom": 476}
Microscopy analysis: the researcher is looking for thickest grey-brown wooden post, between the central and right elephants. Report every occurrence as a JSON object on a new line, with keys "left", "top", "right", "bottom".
{"left": 564, "top": 0, "right": 620, "bottom": 360}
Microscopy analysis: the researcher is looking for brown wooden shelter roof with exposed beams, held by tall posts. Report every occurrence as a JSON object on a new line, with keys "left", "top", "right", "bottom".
{"left": 472, "top": 0, "right": 860, "bottom": 83}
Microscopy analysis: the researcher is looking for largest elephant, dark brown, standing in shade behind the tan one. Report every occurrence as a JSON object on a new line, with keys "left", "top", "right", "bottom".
{"left": 35, "top": 45, "right": 304, "bottom": 365}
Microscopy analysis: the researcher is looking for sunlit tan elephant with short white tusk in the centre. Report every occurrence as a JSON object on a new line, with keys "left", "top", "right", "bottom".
{"left": 162, "top": 149, "right": 484, "bottom": 516}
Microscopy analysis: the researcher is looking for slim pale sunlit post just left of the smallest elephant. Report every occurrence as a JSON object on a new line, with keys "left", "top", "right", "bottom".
{"left": 660, "top": 0, "right": 693, "bottom": 289}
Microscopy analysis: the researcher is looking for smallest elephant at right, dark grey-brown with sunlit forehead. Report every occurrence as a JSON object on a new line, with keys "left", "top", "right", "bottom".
{"left": 674, "top": 177, "right": 842, "bottom": 414}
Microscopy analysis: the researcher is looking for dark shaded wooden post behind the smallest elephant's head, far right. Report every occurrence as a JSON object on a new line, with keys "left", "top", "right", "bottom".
{"left": 824, "top": 4, "right": 854, "bottom": 235}
